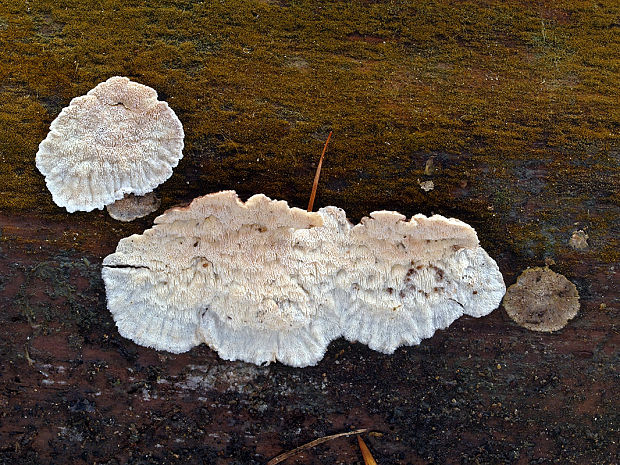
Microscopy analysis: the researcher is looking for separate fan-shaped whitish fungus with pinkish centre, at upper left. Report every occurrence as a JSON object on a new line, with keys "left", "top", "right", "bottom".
{"left": 36, "top": 76, "right": 184, "bottom": 212}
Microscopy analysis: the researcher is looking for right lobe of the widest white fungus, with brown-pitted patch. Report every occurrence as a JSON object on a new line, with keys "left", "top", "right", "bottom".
{"left": 322, "top": 210, "right": 506, "bottom": 353}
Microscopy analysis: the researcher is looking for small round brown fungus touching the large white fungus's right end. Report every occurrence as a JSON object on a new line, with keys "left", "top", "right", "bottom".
{"left": 504, "top": 267, "right": 579, "bottom": 332}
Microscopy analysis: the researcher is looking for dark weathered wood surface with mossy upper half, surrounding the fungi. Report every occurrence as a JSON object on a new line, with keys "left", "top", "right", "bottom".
{"left": 0, "top": 0, "right": 620, "bottom": 465}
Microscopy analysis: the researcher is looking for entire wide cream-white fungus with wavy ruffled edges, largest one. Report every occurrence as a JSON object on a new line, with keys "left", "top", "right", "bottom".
{"left": 103, "top": 191, "right": 505, "bottom": 366}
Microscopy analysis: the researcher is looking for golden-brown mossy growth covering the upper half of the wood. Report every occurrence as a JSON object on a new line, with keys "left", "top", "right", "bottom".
{"left": 0, "top": 0, "right": 620, "bottom": 262}
